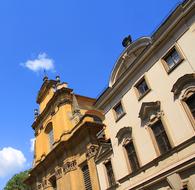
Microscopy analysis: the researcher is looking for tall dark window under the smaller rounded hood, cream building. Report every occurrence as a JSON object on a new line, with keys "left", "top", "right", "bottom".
{"left": 125, "top": 141, "right": 140, "bottom": 172}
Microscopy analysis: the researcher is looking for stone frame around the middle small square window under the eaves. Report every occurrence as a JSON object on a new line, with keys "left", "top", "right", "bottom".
{"left": 134, "top": 75, "right": 151, "bottom": 101}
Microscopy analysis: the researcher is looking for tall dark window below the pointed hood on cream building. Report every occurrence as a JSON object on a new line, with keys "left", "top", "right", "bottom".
{"left": 151, "top": 120, "right": 171, "bottom": 154}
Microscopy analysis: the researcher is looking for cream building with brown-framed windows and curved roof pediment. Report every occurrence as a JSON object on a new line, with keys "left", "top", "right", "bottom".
{"left": 95, "top": 0, "right": 195, "bottom": 190}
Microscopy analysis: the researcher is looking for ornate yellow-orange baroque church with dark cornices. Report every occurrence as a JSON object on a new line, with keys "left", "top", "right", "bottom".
{"left": 26, "top": 77, "right": 103, "bottom": 190}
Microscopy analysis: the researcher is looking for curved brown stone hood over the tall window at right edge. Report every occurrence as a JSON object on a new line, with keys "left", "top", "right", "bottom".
{"left": 171, "top": 73, "right": 195, "bottom": 96}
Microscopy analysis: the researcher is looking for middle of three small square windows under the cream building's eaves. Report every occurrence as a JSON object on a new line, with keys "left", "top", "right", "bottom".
{"left": 135, "top": 77, "right": 150, "bottom": 99}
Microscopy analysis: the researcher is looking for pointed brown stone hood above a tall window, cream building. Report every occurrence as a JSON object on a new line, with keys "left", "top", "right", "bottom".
{"left": 139, "top": 101, "right": 160, "bottom": 120}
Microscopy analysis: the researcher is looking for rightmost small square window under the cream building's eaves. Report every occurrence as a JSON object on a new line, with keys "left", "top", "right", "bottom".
{"left": 163, "top": 47, "right": 183, "bottom": 72}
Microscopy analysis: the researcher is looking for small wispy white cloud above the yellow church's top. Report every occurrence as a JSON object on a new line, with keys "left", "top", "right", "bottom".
{"left": 21, "top": 53, "right": 54, "bottom": 72}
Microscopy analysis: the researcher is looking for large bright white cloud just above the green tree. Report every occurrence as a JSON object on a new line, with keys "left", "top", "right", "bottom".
{"left": 0, "top": 147, "right": 26, "bottom": 177}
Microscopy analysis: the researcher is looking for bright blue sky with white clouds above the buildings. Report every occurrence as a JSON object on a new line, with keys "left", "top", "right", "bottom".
{"left": 0, "top": 0, "right": 181, "bottom": 189}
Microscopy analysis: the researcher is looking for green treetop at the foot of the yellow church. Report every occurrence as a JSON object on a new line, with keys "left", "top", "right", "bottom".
{"left": 4, "top": 170, "right": 29, "bottom": 190}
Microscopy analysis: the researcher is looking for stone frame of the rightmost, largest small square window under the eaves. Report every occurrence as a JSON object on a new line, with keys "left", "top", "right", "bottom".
{"left": 161, "top": 44, "right": 184, "bottom": 74}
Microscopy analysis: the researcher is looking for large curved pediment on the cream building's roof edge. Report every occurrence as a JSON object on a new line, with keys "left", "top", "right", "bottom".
{"left": 109, "top": 37, "right": 151, "bottom": 87}
